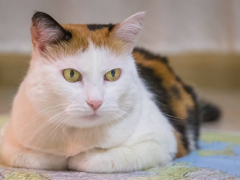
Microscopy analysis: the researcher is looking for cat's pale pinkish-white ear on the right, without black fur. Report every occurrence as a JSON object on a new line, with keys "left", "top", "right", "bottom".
{"left": 113, "top": 12, "right": 146, "bottom": 48}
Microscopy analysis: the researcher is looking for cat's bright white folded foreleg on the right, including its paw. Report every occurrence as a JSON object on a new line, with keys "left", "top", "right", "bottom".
{"left": 68, "top": 142, "right": 175, "bottom": 173}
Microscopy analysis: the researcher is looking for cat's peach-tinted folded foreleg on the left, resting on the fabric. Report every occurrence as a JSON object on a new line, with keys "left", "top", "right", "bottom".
{"left": 1, "top": 139, "right": 67, "bottom": 170}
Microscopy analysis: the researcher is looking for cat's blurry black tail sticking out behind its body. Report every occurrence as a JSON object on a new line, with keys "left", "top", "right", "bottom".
{"left": 200, "top": 100, "right": 222, "bottom": 122}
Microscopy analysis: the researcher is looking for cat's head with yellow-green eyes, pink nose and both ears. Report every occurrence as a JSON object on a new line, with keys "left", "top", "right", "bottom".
{"left": 25, "top": 12, "right": 145, "bottom": 127}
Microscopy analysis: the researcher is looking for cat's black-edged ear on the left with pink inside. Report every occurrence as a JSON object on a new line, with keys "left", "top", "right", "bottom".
{"left": 31, "top": 12, "right": 72, "bottom": 52}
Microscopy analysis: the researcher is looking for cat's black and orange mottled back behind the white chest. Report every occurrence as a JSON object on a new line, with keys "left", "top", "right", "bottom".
{"left": 133, "top": 48, "right": 200, "bottom": 155}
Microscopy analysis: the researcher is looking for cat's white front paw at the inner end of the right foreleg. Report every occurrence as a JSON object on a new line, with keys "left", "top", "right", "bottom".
{"left": 68, "top": 150, "right": 113, "bottom": 173}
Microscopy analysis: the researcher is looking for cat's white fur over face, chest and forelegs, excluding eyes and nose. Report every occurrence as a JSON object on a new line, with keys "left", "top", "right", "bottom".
{"left": 1, "top": 11, "right": 177, "bottom": 172}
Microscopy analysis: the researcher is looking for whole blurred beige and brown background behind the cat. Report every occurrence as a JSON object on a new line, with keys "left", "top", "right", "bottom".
{"left": 0, "top": 0, "right": 240, "bottom": 131}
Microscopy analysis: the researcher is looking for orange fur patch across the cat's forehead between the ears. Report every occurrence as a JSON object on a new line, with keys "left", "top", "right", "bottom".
{"left": 44, "top": 24, "right": 125, "bottom": 59}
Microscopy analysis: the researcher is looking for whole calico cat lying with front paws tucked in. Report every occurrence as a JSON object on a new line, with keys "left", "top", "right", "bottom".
{"left": 1, "top": 12, "right": 220, "bottom": 173}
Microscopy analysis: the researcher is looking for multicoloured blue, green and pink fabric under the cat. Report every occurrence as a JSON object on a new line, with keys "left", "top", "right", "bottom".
{"left": 0, "top": 116, "right": 240, "bottom": 180}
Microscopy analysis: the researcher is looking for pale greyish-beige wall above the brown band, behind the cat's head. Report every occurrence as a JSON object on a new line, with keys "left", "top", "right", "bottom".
{"left": 0, "top": 0, "right": 240, "bottom": 54}
